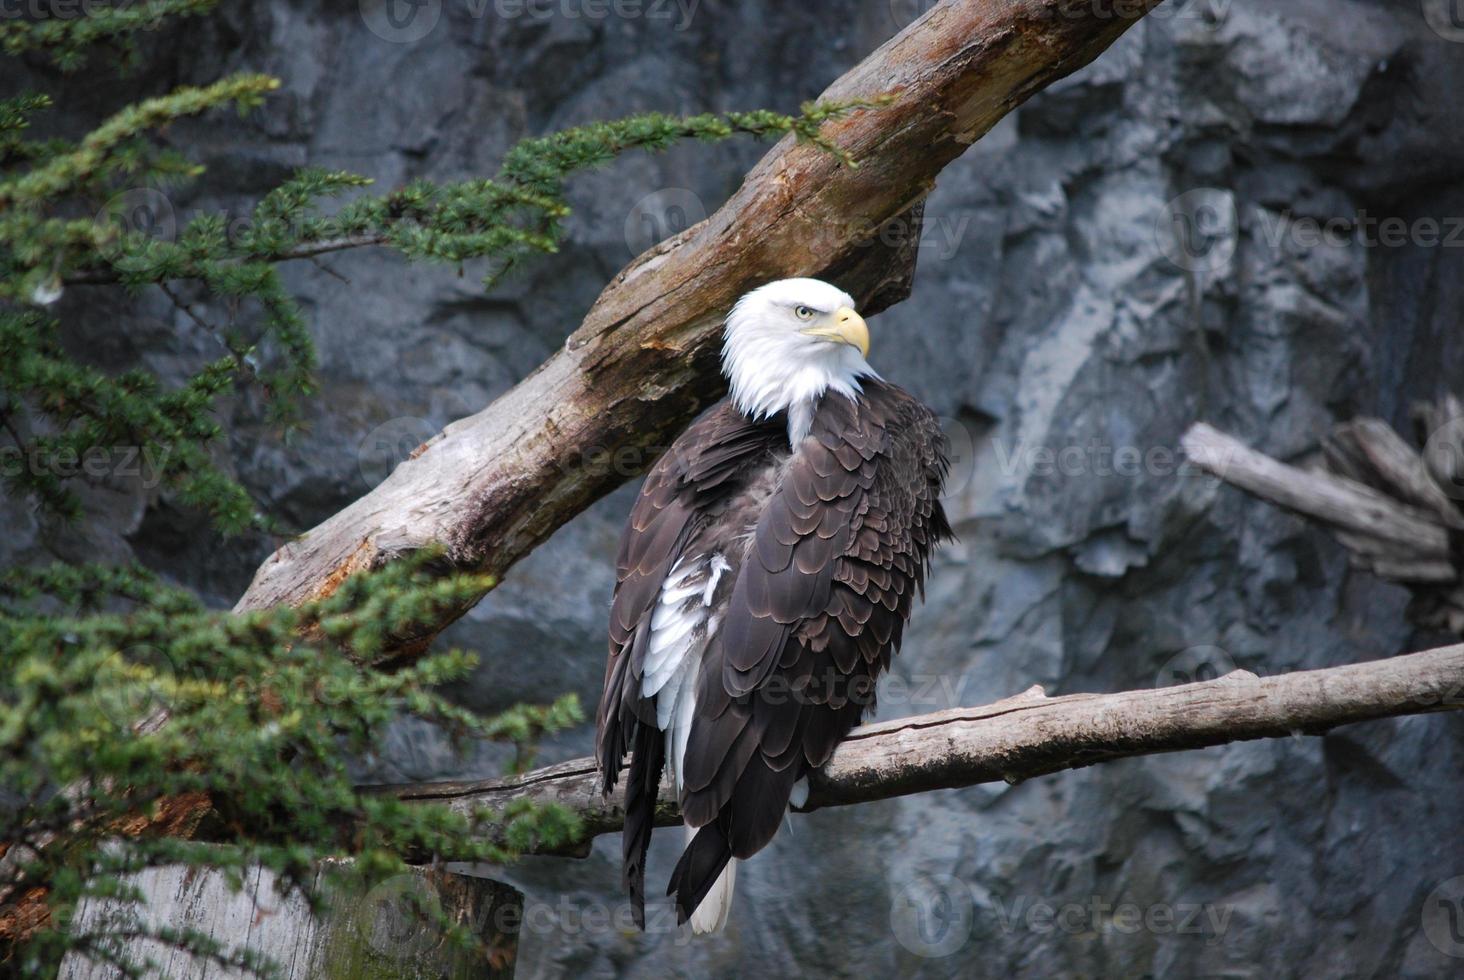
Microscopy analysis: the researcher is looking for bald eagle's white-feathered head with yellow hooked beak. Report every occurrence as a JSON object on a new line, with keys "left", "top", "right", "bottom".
{"left": 722, "top": 278, "right": 874, "bottom": 445}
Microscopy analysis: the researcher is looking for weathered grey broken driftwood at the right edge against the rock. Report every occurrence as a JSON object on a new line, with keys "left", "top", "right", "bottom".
{"left": 1181, "top": 397, "right": 1464, "bottom": 634}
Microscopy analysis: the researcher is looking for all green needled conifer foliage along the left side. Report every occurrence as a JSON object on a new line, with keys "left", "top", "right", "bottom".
{"left": 0, "top": 0, "right": 865, "bottom": 976}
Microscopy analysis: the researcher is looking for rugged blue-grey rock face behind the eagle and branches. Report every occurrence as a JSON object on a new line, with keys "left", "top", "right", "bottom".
{"left": 17, "top": 0, "right": 1464, "bottom": 977}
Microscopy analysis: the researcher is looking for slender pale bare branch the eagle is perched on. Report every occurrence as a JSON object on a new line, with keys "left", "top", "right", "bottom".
{"left": 381, "top": 645, "right": 1464, "bottom": 855}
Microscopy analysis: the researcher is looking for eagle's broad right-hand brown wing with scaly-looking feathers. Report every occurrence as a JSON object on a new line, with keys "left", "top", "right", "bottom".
{"left": 671, "top": 379, "right": 950, "bottom": 920}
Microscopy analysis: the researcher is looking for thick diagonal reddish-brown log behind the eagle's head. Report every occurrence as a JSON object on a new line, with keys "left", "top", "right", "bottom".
{"left": 236, "top": 0, "right": 1158, "bottom": 656}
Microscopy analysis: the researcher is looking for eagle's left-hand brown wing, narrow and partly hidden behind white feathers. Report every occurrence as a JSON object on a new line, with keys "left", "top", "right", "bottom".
{"left": 596, "top": 392, "right": 786, "bottom": 924}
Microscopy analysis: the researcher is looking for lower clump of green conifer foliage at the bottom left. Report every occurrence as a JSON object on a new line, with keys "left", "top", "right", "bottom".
{"left": 0, "top": 558, "right": 581, "bottom": 976}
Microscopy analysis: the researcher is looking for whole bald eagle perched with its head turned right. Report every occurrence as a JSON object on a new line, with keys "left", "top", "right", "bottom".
{"left": 596, "top": 278, "right": 950, "bottom": 932}
